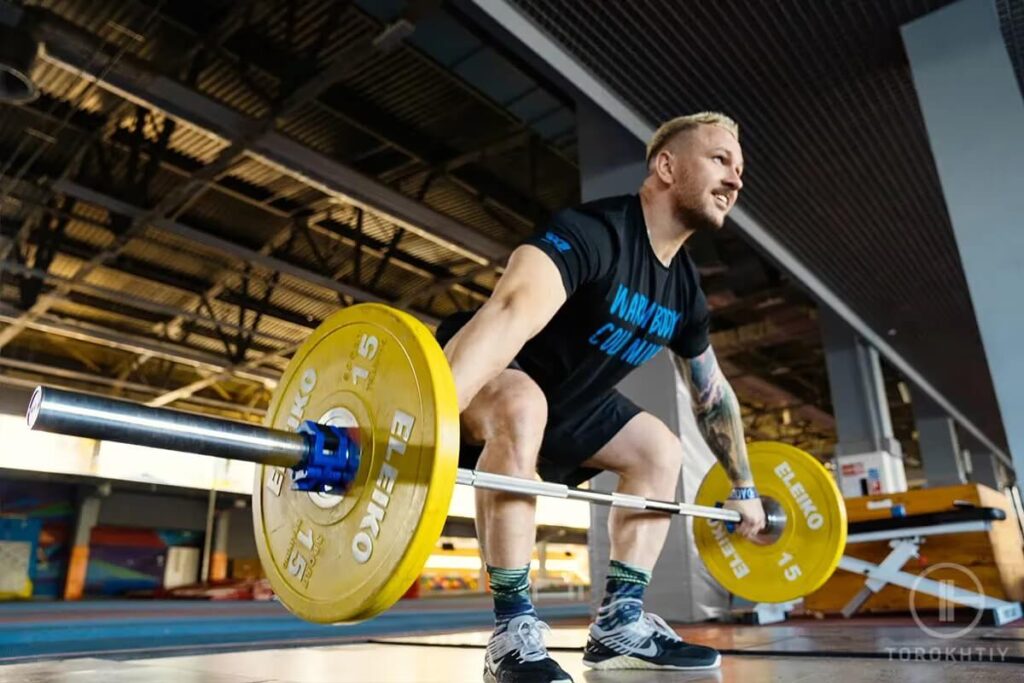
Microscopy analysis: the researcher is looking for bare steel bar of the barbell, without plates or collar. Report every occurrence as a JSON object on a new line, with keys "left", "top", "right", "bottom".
{"left": 26, "top": 387, "right": 741, "bottom": 523}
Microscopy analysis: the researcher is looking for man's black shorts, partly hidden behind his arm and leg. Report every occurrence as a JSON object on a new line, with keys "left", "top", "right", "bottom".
{"left": 436, "top": 312, "right": 641, "bottom": 486}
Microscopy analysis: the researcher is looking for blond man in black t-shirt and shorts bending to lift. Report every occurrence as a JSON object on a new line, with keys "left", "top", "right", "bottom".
{"left": 437, "top": 113, "right": 765, "bottom": 682}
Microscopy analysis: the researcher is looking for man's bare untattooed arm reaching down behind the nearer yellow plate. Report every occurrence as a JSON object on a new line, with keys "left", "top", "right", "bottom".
{"left": 444, "top": 245, "right": 566, "bottom": 412}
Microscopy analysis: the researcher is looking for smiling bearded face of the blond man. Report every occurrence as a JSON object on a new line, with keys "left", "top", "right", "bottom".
{"left": 667, "top": 125, "right": 743, "bottom": 230}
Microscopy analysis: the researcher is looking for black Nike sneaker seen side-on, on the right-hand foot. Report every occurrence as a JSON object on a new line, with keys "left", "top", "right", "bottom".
{"left": 583, "top": 598, "right": 722, "bottom": 671}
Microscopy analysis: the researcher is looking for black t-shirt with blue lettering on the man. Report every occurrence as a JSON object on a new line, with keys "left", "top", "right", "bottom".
{"left": 516, "top": 195, "right": 709, "bottom": 415}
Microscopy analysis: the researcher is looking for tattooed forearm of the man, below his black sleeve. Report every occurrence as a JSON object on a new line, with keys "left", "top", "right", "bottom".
{"left": 677, "top": 346, "right": 752, "bottom": 482}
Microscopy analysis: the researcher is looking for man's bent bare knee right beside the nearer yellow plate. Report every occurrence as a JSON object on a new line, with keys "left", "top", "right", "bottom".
{"left": 462, "top": 370, "right": 548, "bottom": 467}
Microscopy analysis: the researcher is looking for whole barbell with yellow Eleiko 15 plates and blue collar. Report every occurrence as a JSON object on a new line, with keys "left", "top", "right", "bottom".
{"left": 27, "top": 304, "right": 847, "bottom": 623}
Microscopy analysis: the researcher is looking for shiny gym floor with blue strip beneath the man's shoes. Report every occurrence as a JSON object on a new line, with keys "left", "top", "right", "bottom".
{"left": 0, "top": 598, "right": 1024, "bottom": 683}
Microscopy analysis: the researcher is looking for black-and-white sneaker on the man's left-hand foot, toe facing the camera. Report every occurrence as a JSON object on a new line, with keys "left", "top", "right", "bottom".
{"left": 483, "top": 614, "right": 572, "bottom": 683}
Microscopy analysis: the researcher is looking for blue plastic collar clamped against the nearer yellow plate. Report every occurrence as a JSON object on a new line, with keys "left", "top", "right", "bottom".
{"left": 292, "top": 420, "right": 359, "bottom": 494}
